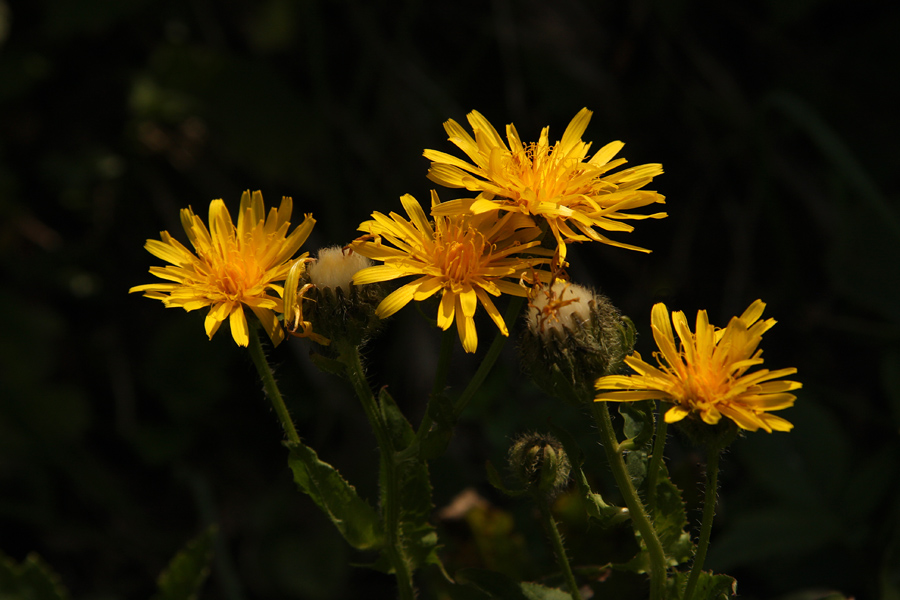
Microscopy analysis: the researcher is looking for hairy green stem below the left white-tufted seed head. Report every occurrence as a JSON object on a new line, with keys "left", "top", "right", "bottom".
{"left": 335, "top": 340, "right": 416, "bottom": 600}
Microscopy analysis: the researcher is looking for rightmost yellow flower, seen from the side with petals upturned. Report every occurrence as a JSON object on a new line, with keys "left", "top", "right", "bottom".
{"left": 595, "top": 300, "right": 801, "bottom": 433}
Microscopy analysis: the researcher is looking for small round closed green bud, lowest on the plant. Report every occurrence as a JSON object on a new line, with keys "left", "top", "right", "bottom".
{"left": 509, "top": 433, "right": 571, "bottom": 499}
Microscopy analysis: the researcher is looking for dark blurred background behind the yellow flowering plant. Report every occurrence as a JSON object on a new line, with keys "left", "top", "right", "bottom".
{"left": 0, "top": 0, "right": 900, "bottom": 600}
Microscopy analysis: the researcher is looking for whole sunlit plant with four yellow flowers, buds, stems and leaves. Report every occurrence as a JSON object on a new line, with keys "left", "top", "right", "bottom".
{"left": 110, "top": 109, "right": 801, "bottom": 600}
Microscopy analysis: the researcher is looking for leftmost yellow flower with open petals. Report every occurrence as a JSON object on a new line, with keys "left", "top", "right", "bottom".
{"left": 128, "top": 191, "right": 316, "bottom": 346}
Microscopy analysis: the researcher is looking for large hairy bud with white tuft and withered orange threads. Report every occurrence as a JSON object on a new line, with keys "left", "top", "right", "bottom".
{"left": 520, "top": 280, "right": 634, "bottom": 405}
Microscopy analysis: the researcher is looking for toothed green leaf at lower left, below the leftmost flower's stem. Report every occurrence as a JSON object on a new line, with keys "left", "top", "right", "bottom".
{"left": 286, "top": 442, "right": 384, "bottom": 550}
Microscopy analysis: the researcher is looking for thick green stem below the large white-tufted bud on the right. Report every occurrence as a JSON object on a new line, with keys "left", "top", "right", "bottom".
{"left": 592, "top": 402, "right": 666, "bottom": 600}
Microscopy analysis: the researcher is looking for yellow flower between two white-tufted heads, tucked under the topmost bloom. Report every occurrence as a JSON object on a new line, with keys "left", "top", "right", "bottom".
{"left": 350, "top": 192, "right": 549, "bottom": 352}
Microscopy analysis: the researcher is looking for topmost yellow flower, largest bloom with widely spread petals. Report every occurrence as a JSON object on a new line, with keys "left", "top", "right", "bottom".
{"left": 424, "top": 108, "right": 666, "bottom": 261}
